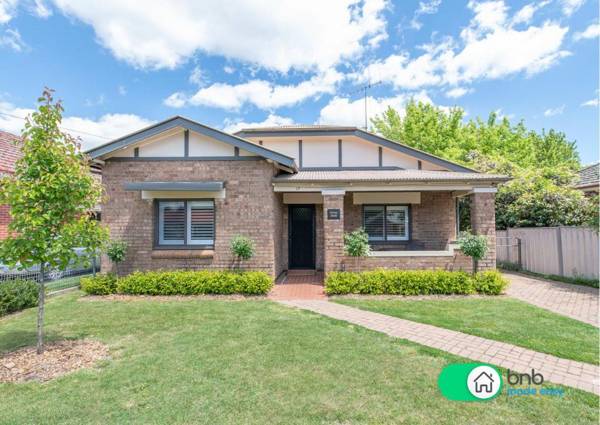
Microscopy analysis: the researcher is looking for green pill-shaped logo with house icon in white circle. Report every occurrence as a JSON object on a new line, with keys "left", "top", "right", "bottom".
{"left": 438, "top": 363, "right": 503, "bottom": 401}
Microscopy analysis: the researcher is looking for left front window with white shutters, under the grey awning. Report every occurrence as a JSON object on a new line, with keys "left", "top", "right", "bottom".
{"left": 157, "top": 201, "right": 215, "bottom": 247}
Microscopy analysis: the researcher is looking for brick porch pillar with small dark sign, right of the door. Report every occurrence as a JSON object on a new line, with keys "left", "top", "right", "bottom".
{"left": 322, "top": 190, "right": 345, "bottom": 275}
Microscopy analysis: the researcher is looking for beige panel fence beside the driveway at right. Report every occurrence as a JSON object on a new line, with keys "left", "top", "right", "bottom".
{"left": 496, "top": 226, "right": 600, "bottom": 279}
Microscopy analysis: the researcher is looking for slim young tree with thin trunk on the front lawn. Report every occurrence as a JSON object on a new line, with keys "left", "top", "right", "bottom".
{"left": 0, "top": 89, "right": 108, "bottom": 354}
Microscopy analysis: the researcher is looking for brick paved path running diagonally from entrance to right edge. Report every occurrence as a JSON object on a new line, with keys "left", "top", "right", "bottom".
{"left": 279, "top": 300, "right": 600, "bottom": 394}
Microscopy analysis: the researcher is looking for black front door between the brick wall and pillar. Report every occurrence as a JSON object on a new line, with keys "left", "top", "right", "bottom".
{"left": 288, "top": 205, "right": 315, "bottom": 269}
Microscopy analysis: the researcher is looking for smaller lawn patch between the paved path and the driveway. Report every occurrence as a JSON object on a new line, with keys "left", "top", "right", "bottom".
{"left": 336, "top": 298, "right": 598, "bottom": 364}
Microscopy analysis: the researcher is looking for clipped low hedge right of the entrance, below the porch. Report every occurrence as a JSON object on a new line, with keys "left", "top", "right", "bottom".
{"left": 325, "top": 269, "right": 508, "bottom": 295}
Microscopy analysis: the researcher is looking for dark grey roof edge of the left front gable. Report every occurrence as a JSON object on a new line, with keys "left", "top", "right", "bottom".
{"left": 87, "top": 116, "right": 297, "bottom": 170}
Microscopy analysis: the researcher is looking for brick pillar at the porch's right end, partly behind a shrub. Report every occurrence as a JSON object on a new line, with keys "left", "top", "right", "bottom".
{"left": 471, "top": 192, "right": 496, "bottom": 270}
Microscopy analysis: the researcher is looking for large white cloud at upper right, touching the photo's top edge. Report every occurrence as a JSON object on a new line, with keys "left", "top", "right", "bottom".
{"left": 352, "top": 1, "right": 570, "bottom": 90}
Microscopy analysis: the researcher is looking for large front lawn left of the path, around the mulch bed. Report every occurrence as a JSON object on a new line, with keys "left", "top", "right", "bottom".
{"left": 0, "top": 293, "right": 599, "bottom": 425}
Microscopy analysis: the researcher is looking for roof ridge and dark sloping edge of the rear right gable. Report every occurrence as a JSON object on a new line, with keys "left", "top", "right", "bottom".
{"left": 235, "top": 125, "right": 477, "bottom": 173}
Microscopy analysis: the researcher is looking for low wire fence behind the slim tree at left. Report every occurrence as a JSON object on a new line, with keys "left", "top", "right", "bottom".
{"left": 0, "top": 255, "right": 100, "bottom": 294}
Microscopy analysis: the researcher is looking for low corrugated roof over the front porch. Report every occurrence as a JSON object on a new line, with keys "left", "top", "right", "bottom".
{"left": 273, "top": 170, "right": 510, "bottom": 183}
